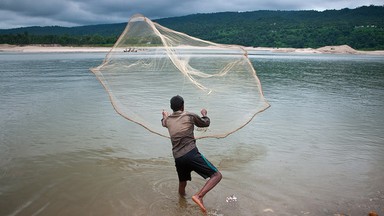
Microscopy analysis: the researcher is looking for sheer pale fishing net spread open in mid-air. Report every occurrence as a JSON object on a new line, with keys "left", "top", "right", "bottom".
{"left": 91, "top": 15, "right": 269, "bottom": 138}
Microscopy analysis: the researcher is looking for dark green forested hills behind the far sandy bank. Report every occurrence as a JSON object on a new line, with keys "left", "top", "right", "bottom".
{"left": 0, "top": 6, "right": 384, "bottom": 50}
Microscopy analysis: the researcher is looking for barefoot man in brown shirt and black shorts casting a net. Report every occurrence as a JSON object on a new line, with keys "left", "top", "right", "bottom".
{"left": 161, "top": 95, "right": 222, "bottom": 212}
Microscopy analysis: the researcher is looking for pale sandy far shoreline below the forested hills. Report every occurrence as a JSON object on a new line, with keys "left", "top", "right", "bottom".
{"left": 0, "top": 44, "right": 384, "bottom": 55}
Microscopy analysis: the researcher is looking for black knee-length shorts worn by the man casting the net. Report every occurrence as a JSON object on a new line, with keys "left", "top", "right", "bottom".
{"left": 175, "top": 148, "right": 218, "bottom": 182}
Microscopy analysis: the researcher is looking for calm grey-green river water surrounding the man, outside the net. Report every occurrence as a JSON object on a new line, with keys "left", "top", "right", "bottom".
{"left": 0, "top": 52, "right": 384, "bottom": 215}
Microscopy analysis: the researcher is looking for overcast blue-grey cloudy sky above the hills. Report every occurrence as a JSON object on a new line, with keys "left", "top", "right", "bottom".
{"left": 0, "top": 0, "right": 384, "bottom": 29}
